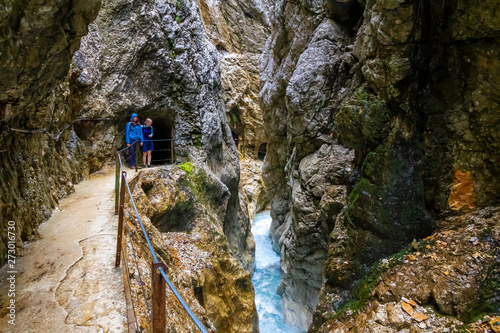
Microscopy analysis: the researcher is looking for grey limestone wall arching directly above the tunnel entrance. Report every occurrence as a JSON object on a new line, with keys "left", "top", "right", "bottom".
{"left": 74, "top": 0, "right": 225, "bottom": 165}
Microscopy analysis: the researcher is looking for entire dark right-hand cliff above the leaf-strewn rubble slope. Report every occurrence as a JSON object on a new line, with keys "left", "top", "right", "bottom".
{"left": 260, "top": 0, "right": 500, "bottom": 331}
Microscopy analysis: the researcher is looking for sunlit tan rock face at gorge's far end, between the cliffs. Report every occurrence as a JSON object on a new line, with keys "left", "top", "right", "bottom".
{"left": 198, "top": 0, "right": 270, "bottom": 157}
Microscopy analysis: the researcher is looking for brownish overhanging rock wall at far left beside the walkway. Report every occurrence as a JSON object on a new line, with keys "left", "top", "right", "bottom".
{"left": 0, "top": 0, "right": 100, "bottom": 265}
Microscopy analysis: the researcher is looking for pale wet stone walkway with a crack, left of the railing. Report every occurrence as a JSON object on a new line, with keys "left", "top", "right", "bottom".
{"left": 0, "top": 170, "right": 127, "bottom": 333}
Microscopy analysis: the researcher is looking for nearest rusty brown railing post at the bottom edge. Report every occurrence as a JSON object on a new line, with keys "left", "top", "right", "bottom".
{"left": 151, "top": 262, "right": 167, "bottom": 333}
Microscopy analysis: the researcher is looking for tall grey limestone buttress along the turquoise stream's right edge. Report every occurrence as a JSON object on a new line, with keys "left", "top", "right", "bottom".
{"left": 260, "top": 1, "right": 362, "bottom": 330}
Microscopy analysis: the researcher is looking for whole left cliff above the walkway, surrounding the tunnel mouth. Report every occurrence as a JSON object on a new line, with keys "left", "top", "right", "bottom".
{"left": 0, "top": 0, "right": 253, "bottom": 282}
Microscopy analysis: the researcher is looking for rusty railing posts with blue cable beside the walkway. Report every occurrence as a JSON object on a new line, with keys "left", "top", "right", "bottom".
{"left": 115, "top": 141, "right": 208, "bottom": 333}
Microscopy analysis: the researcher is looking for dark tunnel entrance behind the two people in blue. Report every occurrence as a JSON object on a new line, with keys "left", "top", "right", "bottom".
{"left": 141, "top": 116, "right": 175, "bottom": 165}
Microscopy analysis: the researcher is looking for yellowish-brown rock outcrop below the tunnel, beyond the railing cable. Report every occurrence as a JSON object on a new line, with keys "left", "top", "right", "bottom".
{"left": 127, "top": 163, "right": 259, "bottom": 332}
